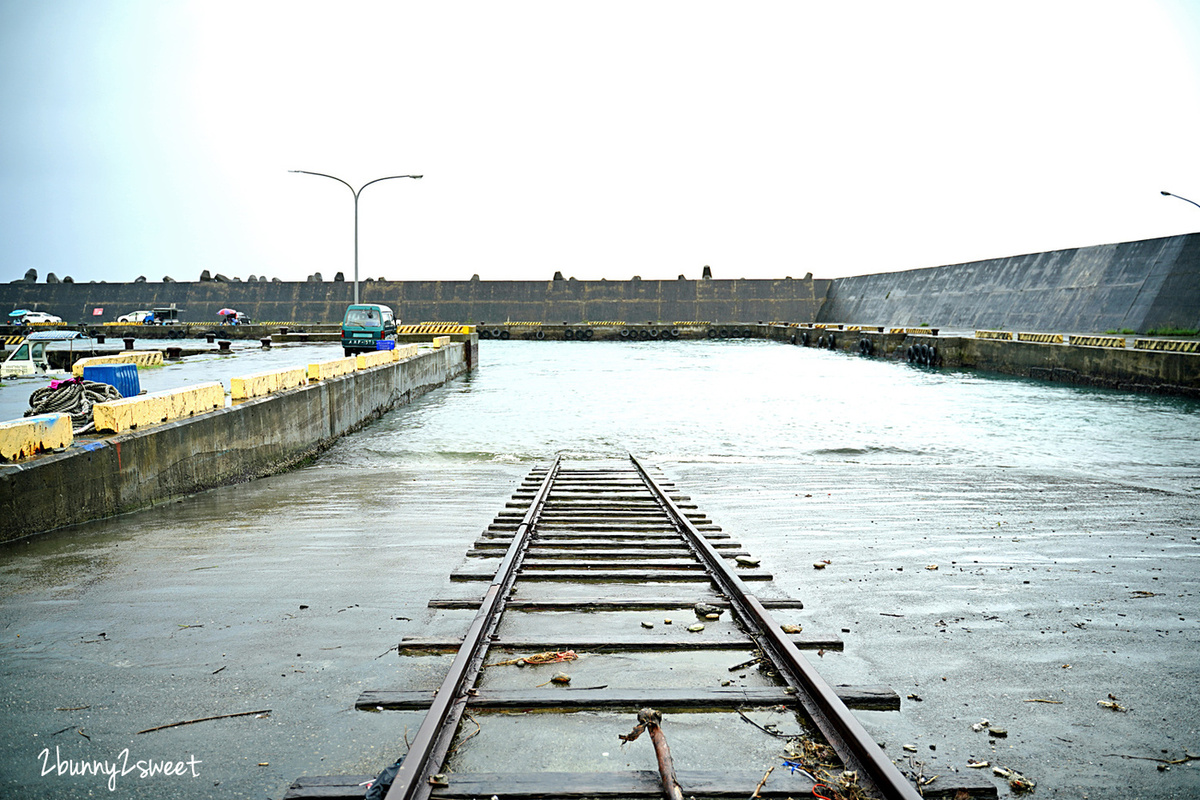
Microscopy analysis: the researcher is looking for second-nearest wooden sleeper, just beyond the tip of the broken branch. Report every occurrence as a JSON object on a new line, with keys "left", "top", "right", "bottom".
{"left": 354, "top": 685, "right": 900, "bottom": 711}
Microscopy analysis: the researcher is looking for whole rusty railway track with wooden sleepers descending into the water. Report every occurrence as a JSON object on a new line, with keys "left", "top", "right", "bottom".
{"left": 284, "top": 456, "right": 996, "bottom": 800}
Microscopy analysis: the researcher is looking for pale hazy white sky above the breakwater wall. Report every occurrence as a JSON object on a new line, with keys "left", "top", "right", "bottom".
{"left": 0, "top": 0, "right": 1200, "bottom": 282}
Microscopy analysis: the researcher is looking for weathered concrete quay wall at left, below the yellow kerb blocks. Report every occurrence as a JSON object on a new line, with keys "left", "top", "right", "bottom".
{"left": 0, "top": 342, "right": 468, "bottom": 541}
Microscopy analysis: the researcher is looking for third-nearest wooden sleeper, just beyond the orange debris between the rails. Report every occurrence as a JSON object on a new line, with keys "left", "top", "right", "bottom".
{"left": 400, "top": 633, "right": 845, "bottom": 655}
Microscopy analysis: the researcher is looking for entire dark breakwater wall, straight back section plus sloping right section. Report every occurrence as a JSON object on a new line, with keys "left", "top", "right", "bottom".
{"left": 0, "top": 234, "right": 1200, "bottom": 333}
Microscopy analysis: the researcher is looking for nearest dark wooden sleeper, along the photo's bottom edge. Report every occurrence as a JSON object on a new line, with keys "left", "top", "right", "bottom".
{"left": 283, "top": 766, "right": 997, "bottom": 800}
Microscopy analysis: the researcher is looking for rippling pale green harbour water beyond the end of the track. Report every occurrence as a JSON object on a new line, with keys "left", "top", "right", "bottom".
{"left": 325, "top": 341, "right": 1200, "bottom": 492}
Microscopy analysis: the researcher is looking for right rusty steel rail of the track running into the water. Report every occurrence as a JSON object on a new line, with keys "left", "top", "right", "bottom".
{"left": 629, "top": 453, "right": 920, "bottom": 800}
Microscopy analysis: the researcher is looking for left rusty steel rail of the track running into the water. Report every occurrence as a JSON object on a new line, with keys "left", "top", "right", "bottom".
{"left": 385, "top": 456, "right": 562, "bottom": 800}
